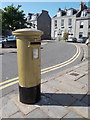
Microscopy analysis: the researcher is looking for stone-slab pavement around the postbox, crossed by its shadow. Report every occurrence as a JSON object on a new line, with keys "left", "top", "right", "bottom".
{"left": 0, "top": 41, "right": 90, "bottom": 120}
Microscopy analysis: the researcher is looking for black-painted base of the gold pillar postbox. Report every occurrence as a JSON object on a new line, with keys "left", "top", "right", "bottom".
{"left": 19, "top": 85, "right": 41, "bottom": 104}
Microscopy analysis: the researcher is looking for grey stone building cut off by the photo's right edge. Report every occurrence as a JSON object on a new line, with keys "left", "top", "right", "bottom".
{"left": 75, "top": 2, "right": 90, "bottom": 38}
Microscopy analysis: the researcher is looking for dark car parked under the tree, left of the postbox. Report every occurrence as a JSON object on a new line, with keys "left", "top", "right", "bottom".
{"left": 2, "top": 35, "right": 16, "bottom": 48}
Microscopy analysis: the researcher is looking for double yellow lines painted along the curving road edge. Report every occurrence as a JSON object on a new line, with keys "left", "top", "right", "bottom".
{"left": 0, "top": 45, "right": 80, "bottom": 90}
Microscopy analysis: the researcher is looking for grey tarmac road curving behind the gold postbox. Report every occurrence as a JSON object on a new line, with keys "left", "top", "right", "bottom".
{"left": 0, "top": 42, "right": 82, "bottom": 82}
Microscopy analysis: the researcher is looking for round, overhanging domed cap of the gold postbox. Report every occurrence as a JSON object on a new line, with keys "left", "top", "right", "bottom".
{"left": 13, "top": 28, "right": 43, "bottom": 36}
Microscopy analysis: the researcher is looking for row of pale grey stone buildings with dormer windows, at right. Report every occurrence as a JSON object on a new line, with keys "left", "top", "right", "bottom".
{"left": 51, "top": 2, "right": 90, "bottom": 39}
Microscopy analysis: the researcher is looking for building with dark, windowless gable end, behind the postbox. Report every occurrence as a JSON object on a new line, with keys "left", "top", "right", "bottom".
{"left": 27, "top": 10, "right": 51, "bottom": 39}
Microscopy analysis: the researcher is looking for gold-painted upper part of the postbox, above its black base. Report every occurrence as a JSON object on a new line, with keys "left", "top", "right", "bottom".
{"left": 13, "top": 30, "right": 42, "bottom": 88}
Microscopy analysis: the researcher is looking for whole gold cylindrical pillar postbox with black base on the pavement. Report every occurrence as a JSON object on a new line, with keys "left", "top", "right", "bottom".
{"left": 13, "top": 28, "right": 43, "bottom": 104}
